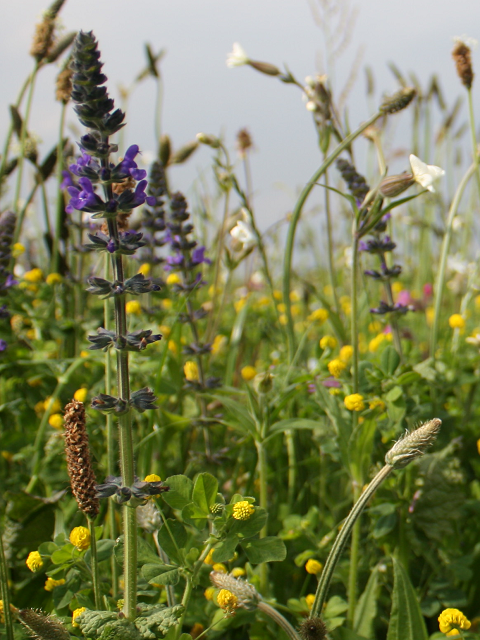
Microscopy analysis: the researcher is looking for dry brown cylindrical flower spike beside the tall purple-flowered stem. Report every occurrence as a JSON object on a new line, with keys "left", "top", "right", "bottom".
{"left": 64, "top": 400, "right": 100, "bottom": 520}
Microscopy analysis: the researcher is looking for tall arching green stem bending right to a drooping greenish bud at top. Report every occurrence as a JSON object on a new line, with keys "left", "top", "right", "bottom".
{"left": 283, "top": 111, "right": 383, "bottom": 360}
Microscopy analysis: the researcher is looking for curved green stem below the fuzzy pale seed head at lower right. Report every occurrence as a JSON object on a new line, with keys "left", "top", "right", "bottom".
{"left": 310, "top": 464, "right": 393, "bottom": 618}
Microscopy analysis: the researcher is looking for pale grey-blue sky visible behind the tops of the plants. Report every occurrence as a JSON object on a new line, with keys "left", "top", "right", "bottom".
{"left": 0, "top": 0, "right": 480, "bottom": 230}
